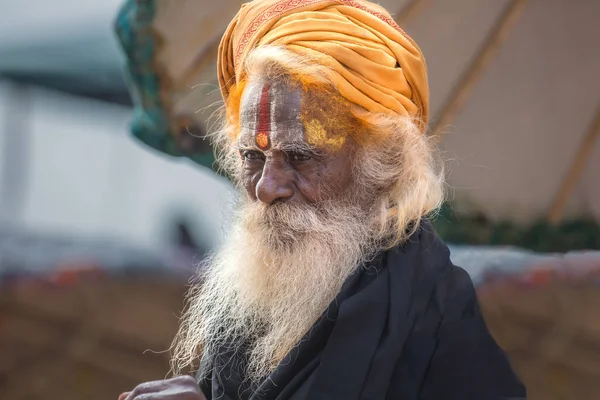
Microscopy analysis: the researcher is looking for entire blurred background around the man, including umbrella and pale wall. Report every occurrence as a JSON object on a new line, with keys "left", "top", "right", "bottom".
{"left": 0, "top": 0, "right": 600, "bottom": 400}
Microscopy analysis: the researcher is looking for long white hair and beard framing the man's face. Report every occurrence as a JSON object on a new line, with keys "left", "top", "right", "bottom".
{"left": 172, "top": 47, "right": 444, "bottom": 382}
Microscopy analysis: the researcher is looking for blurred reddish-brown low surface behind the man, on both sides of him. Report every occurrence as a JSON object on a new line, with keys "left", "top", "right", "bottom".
{"left": 0, "top": 255, "right": 600, "bottom": 400}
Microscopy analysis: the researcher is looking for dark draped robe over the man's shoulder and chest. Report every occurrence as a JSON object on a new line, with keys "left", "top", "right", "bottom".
{"left": 200, "top": 222, "right": 525, "bottom": 400}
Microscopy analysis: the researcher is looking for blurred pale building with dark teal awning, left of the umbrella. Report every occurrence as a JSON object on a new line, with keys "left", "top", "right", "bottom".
{"left": 0, "top": 1, "right": 231, "bottom": 256}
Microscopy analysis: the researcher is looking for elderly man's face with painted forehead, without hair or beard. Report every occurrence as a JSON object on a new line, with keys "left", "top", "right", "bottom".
{"left": 239, "top": 80, "right": 356, "bottom": 205}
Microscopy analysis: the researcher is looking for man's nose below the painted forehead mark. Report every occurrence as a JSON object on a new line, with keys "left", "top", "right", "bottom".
{"left": 256, "top": 160, "right": 294, "bottom": 205}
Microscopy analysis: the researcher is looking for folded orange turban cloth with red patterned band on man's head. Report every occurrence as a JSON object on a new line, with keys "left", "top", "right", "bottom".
{"left": 218, "top": 0, "right": 429, "bottom": 130}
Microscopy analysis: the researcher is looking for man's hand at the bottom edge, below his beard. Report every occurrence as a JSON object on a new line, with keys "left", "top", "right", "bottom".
{"left": 119, "top": 375, "right": 206, "bottom": 400}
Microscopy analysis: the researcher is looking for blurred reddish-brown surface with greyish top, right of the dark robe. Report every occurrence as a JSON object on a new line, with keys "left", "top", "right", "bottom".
{"left": 478, "top": 254, "right": 600, "bottom": 400}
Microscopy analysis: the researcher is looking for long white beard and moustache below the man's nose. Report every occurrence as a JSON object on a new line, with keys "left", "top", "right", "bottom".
{"left": 174, "top": 200, "right": 379, "bottom": 383}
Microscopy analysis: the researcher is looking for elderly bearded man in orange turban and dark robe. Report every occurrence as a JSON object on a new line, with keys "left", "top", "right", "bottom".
{"left": 121, "top": 0, "right": 525, "bottom": 400}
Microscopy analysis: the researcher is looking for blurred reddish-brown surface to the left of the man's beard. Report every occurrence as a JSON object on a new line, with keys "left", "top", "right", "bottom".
{"left": 0, "top": 278, "right": 185, "bottom": 400}
